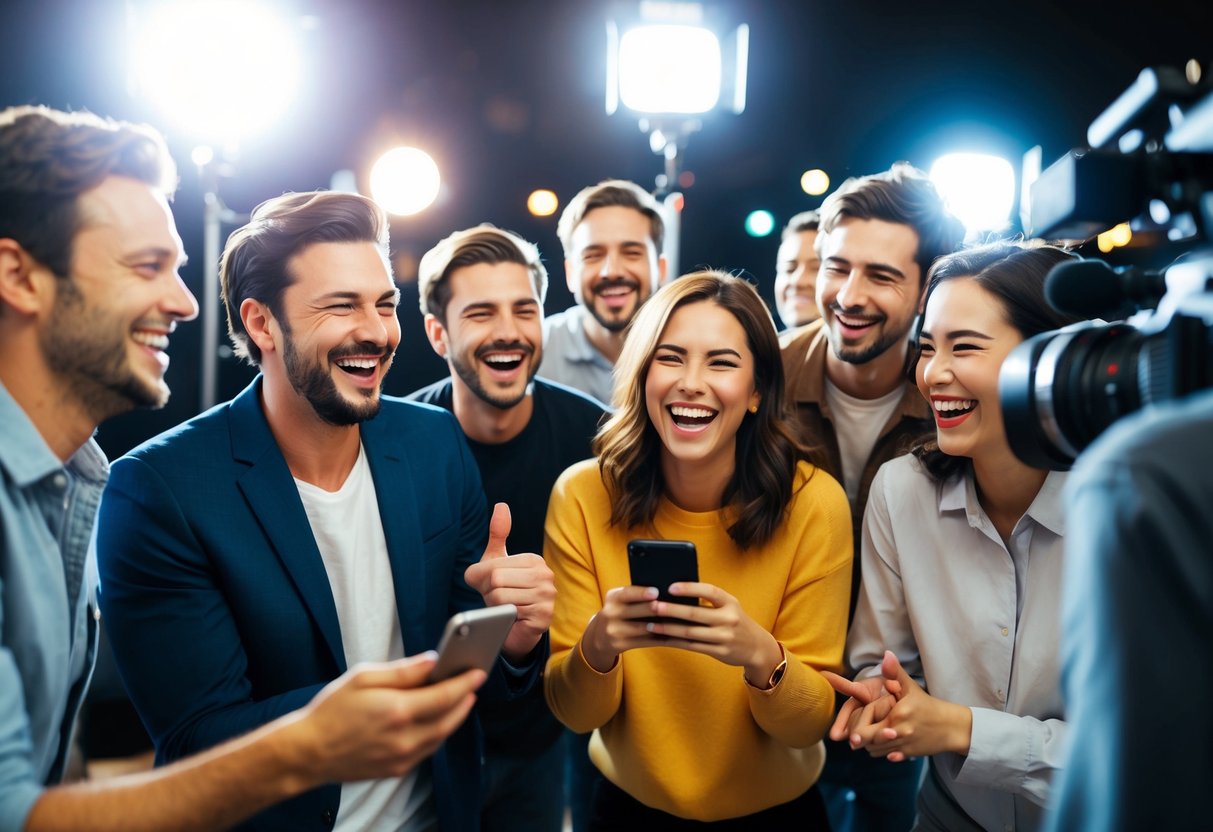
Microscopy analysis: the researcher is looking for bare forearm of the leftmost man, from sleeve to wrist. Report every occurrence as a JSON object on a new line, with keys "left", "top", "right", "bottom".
{"left": 25, "top": 717, "right": 321, "bottom": 832}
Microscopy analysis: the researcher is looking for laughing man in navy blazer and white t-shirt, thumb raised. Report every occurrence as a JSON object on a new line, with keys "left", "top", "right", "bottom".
{"left": 97, "top": 193, "right": 556, "bottom": 830}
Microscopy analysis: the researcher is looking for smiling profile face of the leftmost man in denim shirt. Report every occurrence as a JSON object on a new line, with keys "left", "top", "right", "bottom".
{"left": 39, "top": 176, "right": 198, "bottom": 421}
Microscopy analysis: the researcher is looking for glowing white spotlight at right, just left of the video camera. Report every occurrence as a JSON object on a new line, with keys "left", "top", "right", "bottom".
{"left": 930, "top": 153, "right": 1015, "bottom": 233}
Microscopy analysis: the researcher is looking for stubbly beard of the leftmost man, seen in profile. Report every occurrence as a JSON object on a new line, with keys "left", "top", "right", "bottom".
{"left": 39, "top": 278, "right": 169, "bottom": 422}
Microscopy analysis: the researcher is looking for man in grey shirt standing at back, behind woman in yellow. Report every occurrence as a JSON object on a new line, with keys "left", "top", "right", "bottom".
{"left": 539, "top": 179, "right": 666, "bottom": 404}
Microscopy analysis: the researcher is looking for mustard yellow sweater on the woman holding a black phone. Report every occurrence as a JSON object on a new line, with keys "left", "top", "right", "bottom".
{"left": 543, "top": 460, "right": 852, "bottom": 821}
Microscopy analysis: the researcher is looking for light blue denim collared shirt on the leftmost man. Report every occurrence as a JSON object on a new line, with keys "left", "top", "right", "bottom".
{"left": 0, "top": 384, "right": 102, "bottom": 832}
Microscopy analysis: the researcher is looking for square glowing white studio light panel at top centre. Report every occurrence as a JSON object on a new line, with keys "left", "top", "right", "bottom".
{"left": 619, "top": 24, "right": 721, "bottom": 114}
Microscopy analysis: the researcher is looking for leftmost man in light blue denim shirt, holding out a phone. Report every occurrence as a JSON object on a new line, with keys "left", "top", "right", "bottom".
{"left": 0, "top": 107, "right": 484, "bottom": 832}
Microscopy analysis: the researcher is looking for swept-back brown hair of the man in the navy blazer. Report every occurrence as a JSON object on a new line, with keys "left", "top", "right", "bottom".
{"left": 220, "top": 190, "right": 388, "bottom": 366}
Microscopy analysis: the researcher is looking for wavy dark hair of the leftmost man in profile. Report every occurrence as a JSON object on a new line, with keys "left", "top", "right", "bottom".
{"left": 0, "top": 106, "right": 177, "bottom": 278}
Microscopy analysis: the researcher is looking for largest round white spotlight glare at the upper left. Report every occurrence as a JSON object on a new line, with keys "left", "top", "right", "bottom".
{"left": 130, "top": 0, "right": 300, "bottom": 143}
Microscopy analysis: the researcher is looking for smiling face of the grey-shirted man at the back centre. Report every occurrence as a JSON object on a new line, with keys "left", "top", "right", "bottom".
{"left": 564, "top": 205, "right": 665, "bottom": 332}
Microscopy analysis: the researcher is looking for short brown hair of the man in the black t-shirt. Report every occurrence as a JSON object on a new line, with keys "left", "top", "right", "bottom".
{"left": 417, "top": 223, "right": 547, "bottom": 326}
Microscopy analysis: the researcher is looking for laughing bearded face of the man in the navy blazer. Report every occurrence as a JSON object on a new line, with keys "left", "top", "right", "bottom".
{"left": 272, "top": 243, "right": 400, "bottom": 424}
